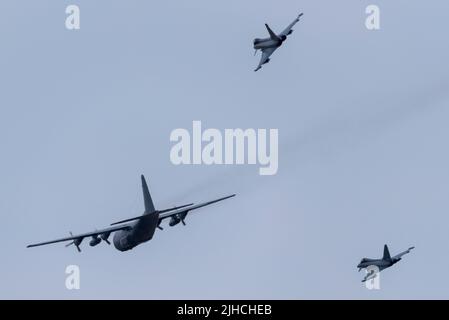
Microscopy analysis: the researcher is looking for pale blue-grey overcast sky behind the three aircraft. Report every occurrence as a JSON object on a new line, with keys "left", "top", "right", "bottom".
{"left": 0, "top": 0, "right": 449, "bottom": 299}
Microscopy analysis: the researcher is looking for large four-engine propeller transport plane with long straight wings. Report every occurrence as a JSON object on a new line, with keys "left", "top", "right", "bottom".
{"left": 27, "top": 175, "right": 235, "bottom": 252}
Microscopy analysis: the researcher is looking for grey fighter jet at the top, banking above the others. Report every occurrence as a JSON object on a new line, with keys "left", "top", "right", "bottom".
{"left": 254, "top": 13, "right": 303, "bottom": 71}
